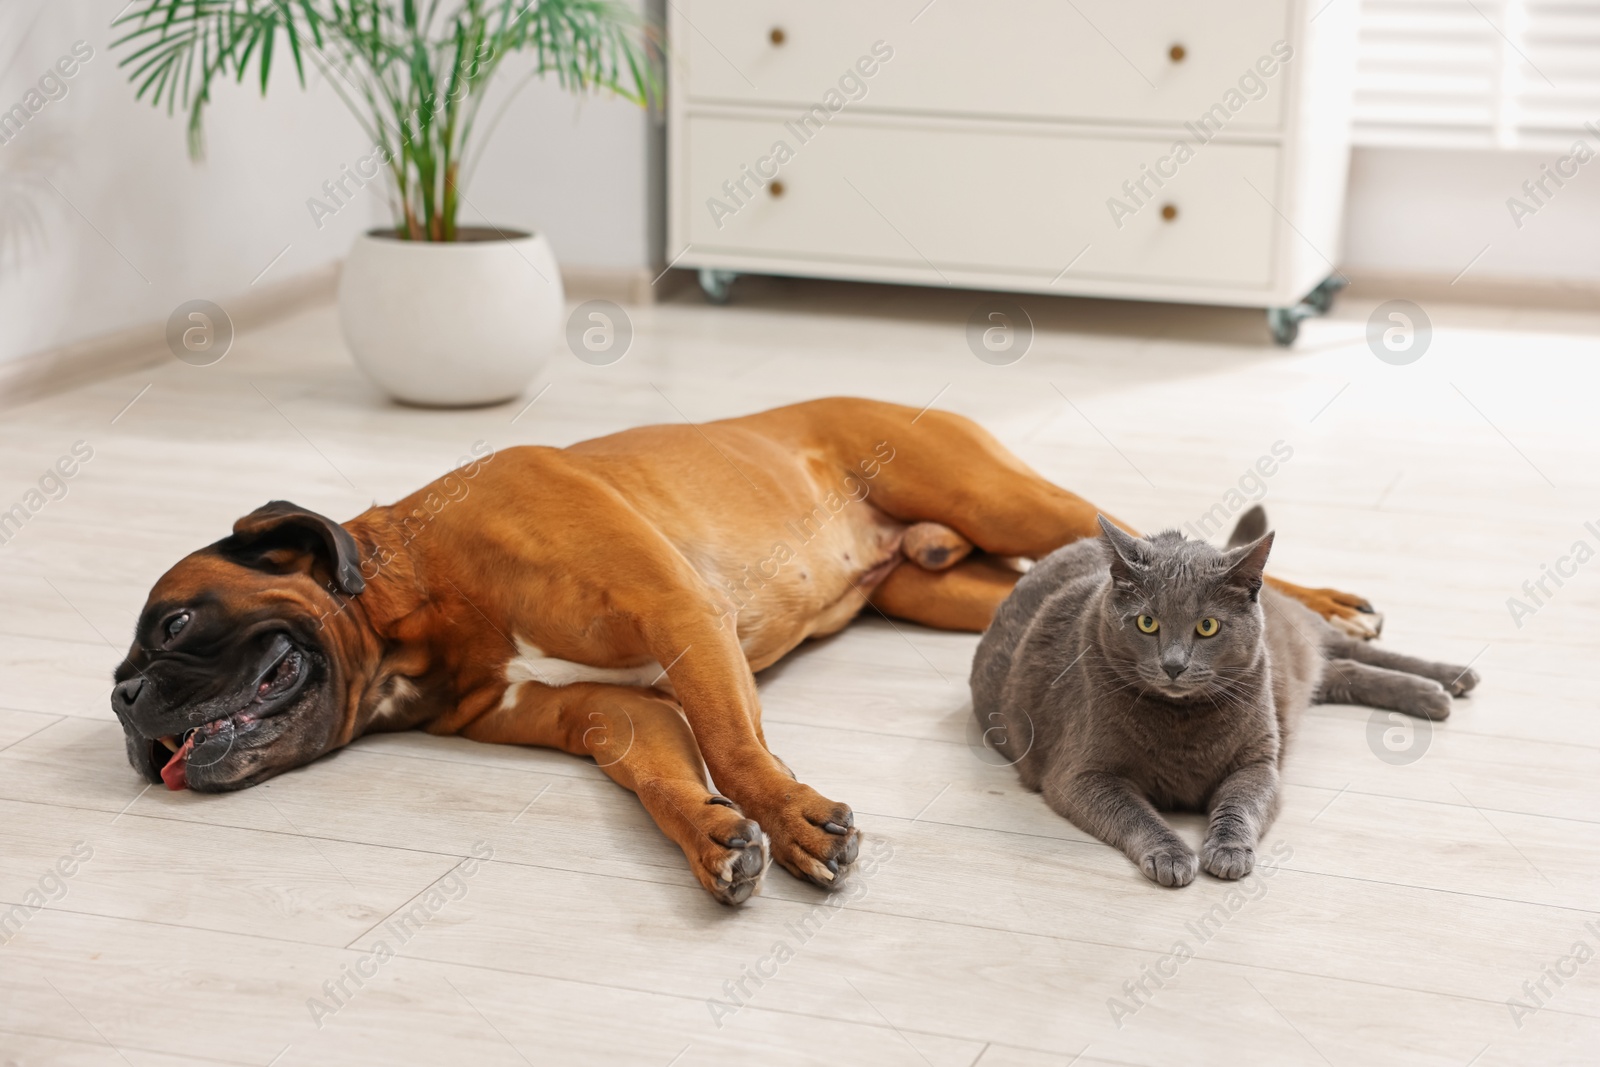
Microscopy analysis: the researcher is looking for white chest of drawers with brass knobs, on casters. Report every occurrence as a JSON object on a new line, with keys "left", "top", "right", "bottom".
{"left": 666, "top": 0, "right": 1355, "bottom": 341}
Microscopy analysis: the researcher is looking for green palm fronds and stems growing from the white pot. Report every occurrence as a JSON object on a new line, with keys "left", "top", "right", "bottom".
{"left": 112, "top": 0, "right": 661, "bottom": 240}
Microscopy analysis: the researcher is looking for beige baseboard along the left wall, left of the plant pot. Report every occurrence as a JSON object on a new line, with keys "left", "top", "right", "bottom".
{"left": 0, "top": 262, "right": 341, "bottom": 410}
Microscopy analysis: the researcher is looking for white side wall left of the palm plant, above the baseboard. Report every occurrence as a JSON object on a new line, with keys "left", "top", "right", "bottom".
{"left": 0, "top": 0, "right": 366, "bottom": 367}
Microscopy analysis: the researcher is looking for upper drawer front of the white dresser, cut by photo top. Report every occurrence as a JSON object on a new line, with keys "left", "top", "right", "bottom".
{"left": 674, "top": 0, "right": 1293, "bottom": 130}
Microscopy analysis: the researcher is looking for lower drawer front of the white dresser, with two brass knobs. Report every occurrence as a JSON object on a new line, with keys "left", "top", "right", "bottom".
{"left": 674, "top": 115, "right": 1278, "bottom": 286}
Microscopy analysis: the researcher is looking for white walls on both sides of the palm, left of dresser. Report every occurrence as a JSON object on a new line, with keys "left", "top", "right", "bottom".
{"left": 0, "top": 0, "right": 654, "bottom": 371}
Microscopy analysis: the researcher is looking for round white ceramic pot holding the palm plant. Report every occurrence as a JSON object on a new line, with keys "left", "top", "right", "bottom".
{"left": 339, "top": 227, "right": 566, "bottom": 408}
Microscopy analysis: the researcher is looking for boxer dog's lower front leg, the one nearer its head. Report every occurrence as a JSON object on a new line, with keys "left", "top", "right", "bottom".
{"left": 462, "top": 681, "right": 771, "bottom": 904}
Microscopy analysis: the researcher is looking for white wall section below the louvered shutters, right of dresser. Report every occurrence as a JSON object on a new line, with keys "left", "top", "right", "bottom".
{"left": 1344, "top": 147, "right": 1600, "bottom": 283}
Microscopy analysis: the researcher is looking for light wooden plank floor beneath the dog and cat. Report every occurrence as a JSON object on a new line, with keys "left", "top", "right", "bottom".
{"left": 0, "top": 282, "right": 1600, "bottom": 1067}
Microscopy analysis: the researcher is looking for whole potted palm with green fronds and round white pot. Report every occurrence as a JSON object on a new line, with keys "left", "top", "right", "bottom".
{"left": 114, "top": 0, "right": 659, "bottom": 406}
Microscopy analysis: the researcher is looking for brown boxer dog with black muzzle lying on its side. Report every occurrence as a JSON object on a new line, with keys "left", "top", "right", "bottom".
{"left": 112, "top": 398, "right": 1376, "bottom": 904}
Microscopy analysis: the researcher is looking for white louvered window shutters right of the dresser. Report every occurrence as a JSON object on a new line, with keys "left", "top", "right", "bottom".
{"left": 1355, "top": 0, "right": 1600, "bottom": 149}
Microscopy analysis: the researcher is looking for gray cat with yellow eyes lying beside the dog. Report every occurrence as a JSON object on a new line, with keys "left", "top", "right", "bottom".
{"left": 971, "top": 507, "right": 1478, "bottom": 886}
